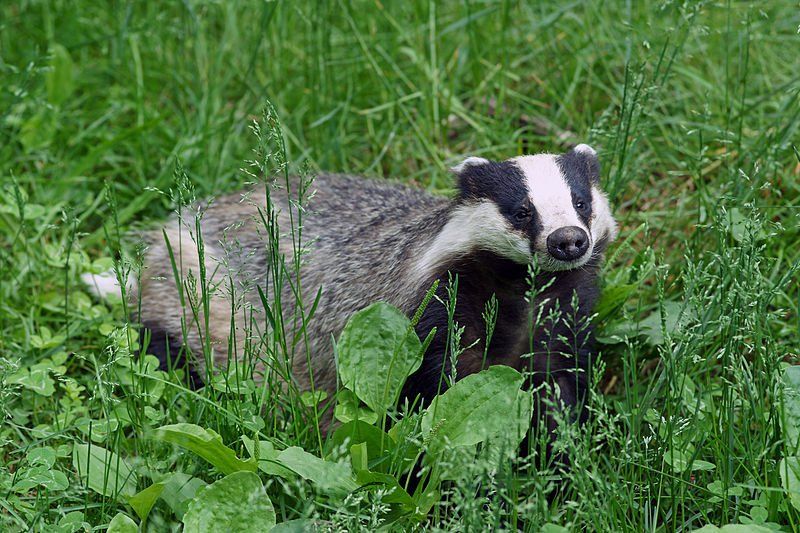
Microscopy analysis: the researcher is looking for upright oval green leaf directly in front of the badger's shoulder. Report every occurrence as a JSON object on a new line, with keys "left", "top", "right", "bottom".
{"left": 336, "top": 302, "right": 422, "bottom": 415}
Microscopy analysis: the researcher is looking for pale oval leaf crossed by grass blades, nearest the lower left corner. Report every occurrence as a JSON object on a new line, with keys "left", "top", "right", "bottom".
{"left": 72, "top": 444, "right": 136, "bottom": 501}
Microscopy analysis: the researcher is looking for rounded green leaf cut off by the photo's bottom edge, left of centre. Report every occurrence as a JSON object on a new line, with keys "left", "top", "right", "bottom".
{"left": 183, "top": 472, "right": 275, "bottom": 533}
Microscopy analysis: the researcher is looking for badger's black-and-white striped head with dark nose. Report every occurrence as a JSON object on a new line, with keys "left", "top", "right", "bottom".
{"left": 425, "top": 144, "right": 617, "bottom": 271}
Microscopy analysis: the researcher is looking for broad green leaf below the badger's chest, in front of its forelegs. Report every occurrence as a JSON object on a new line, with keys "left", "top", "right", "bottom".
{"left": 422, "top": 365, "right": 531, "bottom": 455}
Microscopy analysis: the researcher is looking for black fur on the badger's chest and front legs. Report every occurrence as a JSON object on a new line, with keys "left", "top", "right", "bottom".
{"left": 404, "top": 252, "right": 598, "bottom": 440}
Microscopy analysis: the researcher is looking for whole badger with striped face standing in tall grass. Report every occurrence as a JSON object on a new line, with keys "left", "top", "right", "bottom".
{"left": 87, "top": 144, "right": 617, "bottom": 436}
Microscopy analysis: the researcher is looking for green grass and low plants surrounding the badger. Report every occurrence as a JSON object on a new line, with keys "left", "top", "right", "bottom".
{"left": 0, "top": 0, "right": 800, "bottom": 531}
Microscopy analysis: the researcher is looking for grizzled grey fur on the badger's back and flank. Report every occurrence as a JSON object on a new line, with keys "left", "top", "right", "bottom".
{"left": 139, "top": 174, "right": 451, "bottom": 392}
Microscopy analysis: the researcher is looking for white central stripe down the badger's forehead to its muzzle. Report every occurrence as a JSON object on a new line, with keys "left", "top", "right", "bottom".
{"left": 514, "top": 154, "right": 594, "bottom": 251}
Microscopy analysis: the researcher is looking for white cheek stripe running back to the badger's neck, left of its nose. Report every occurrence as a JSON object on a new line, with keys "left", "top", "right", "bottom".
{"left": 415, "top": 200, "right": 531, "bottom": 277}
